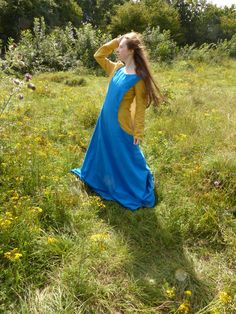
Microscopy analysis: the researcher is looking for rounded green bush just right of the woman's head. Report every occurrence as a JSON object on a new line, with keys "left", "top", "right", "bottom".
{"left": 143, "top": 26, "right": 178, "bottom": 61}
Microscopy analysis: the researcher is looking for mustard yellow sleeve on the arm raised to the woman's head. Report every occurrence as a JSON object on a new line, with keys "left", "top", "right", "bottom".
{"left": 93, "top": 38, "right": 119, "bottom": 75}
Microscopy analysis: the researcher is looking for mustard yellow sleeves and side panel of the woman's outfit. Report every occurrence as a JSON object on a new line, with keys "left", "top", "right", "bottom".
{"left": 94, "top": 38, "right": 147, "bottom": 139}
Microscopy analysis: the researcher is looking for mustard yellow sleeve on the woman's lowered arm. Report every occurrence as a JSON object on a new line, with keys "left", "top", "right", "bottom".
{"left": 134, "top": 79, "right": 147, "bottom": 139}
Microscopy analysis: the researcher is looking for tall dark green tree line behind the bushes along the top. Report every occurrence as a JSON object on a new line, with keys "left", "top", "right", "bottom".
{"left": 0, "top": 0, "right": 236, "bottom": 46}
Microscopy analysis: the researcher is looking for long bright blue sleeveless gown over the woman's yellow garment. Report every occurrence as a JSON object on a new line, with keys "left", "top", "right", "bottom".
{"left": 70, "top": 66, "right": 155, "bottom": 210}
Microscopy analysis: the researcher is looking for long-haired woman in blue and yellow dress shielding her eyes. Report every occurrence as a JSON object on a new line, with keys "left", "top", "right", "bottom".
{"left": 70, "top": 32, "right": 161, "bottom": 210}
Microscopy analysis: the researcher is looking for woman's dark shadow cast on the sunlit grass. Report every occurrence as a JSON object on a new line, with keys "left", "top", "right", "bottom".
{"left": 96, "top": 196, "right": 212, "bottom": 313}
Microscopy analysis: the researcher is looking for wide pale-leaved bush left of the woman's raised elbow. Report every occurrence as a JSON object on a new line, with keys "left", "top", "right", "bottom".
{"left": 1, "top": 17, "right": 109, "bottom": 73}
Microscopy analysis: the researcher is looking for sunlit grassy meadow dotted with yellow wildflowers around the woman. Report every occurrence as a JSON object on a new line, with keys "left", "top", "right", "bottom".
{"left": 0, "top": 59, "right": 236, "bottom": 314}
